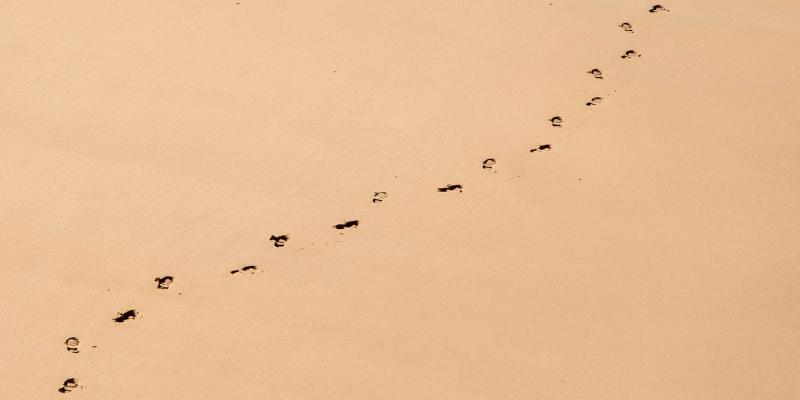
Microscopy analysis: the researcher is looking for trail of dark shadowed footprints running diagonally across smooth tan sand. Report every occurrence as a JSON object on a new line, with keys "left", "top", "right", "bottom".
{"left": 58, "top": 4, "right": 670, "bottom": 394}
